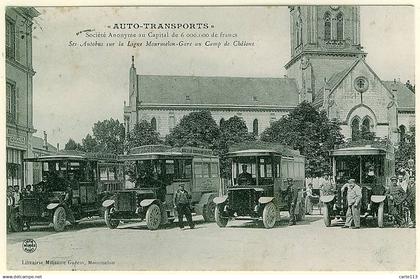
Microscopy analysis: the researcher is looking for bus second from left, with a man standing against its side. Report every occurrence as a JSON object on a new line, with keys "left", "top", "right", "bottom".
{"left": 103, "top": 145, "right": 220, "bottom": 230}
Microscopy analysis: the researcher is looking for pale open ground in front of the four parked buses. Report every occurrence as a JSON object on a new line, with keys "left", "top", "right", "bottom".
{"left": 7, "top": 216, "right": 416, "bottom": 271}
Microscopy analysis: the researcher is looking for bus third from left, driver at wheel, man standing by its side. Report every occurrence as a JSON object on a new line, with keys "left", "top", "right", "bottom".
{"left": 214, "top": 143, "right": 305, "bottom": 228}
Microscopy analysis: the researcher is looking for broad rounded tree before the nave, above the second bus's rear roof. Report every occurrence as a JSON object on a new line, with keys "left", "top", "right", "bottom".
{"left": 165, "top": 110, "right": 220, "bottom": 149}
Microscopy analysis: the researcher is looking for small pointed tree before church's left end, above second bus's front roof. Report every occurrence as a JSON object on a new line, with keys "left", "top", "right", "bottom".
{"left": 126, "top": 120, "right": 163, "bottom": 149}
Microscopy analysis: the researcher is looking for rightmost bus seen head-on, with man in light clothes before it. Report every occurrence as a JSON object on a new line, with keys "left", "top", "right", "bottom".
{"left": 321, "top": 142, "right": 395, "bottom": 228}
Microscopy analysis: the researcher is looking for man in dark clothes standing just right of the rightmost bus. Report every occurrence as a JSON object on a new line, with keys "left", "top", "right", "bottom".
{"left": 388, "top": 176, "right": 406, "bottom": 227}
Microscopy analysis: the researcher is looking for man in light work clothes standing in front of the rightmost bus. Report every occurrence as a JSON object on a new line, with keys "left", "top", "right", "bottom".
{"left": 341, "top": 179, "right": 362, "bottom": 229}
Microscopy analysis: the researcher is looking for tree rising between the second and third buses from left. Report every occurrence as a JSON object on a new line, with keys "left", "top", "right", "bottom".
{"left": 217, "top": 116, "right": 255, "bottom": 178}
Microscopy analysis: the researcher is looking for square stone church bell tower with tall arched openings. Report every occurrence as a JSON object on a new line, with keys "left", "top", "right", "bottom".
{"left": 285, "top": 6, "right": 366, "bottom": 102}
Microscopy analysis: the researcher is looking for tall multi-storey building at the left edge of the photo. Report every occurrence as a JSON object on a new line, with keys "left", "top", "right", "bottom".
{"left": 6, "top": 7, "right": 39, "bottom": 190}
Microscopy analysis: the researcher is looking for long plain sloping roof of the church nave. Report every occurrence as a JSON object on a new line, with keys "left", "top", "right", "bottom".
{"left": 137, "top": 75, "right": 299, "bottom": 108}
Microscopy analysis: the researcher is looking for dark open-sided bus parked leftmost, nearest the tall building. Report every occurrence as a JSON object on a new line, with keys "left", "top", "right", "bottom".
{"left": 9, "top": 151, "right": 124, "bottom": 231}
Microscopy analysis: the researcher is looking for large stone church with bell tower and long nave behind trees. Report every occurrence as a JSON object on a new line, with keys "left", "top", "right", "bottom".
{"left": 124, "top": 6, "right": 415, "bottom": 144}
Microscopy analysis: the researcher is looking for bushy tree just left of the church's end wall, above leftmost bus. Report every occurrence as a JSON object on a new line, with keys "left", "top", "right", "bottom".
{"left": 92, "top": 118, "right": 125, "bottom": 154}
